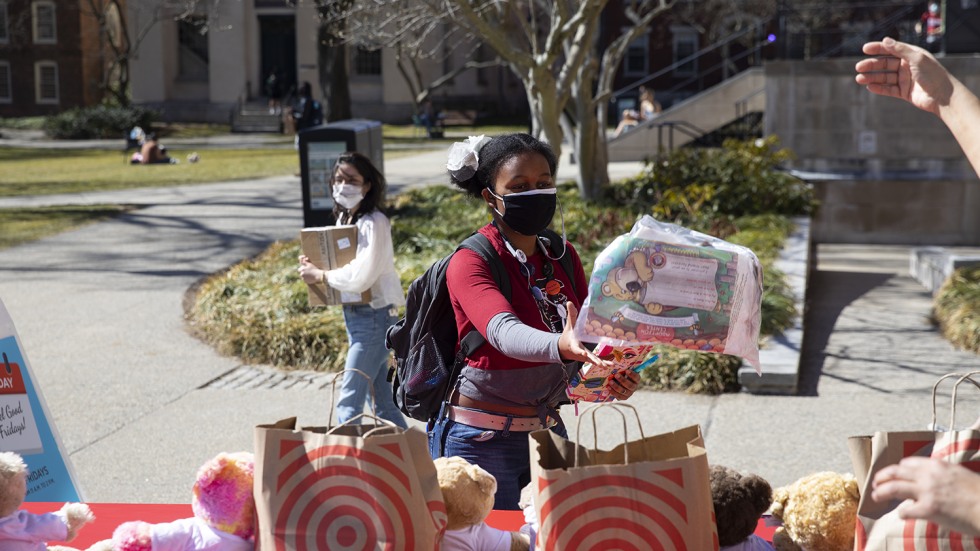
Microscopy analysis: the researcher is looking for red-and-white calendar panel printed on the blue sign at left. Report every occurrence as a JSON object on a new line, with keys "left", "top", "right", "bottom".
{"left": 0, "top": 354, "right": 44, "bottom": 455}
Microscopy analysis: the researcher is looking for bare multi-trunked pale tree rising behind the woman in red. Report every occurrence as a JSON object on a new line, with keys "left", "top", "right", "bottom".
{"left": 425, "top": 0, "right": 673, "bottom": 199}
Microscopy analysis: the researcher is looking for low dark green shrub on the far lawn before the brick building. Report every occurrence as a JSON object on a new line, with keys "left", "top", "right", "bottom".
{"left": 44, "top": 105, "right": 157, "bottom": 140}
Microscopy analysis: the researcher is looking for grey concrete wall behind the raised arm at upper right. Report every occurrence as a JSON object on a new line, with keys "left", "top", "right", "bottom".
{"left": 765, "top": 56, "right": 980, "bottom": 176}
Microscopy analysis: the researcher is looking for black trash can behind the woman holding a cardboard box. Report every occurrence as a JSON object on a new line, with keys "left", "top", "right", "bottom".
{"left": 297, "top": 119, "right": 384, "bottom": 228}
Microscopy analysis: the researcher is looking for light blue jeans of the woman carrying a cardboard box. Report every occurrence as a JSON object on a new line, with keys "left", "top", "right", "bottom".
{"left": 336, "top": 304, "right": 408, "bottom": 428}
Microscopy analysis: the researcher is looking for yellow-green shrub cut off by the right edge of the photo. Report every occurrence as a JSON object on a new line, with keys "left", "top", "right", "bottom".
{"left": 934, "top": 266, "right": 980, "bottom": 353}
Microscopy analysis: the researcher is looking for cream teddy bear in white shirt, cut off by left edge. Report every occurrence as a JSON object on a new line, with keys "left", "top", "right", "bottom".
{"left": 0, "top": 452, "right": 95, "bottom": 551}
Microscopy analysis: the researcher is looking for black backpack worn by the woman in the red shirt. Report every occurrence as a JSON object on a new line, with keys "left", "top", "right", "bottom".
{"left": 385, "top": 230, "right": 575, "bottom": 421}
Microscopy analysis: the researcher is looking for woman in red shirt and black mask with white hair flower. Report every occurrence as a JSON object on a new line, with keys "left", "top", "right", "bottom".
{"left": 436, "top": 134, "right": 639, "bottom": 509}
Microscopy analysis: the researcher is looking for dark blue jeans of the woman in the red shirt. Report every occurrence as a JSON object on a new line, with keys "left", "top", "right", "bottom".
{"left": 428, "top": 415, "right": 568, "bottom": 511}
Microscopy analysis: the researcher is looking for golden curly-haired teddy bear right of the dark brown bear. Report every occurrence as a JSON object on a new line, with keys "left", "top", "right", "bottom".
{"left": 771, "top": 471, "right": 861, "bottom": 551}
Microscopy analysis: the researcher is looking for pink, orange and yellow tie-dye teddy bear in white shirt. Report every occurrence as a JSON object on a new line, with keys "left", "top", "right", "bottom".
{"left": 88, "top": 452, "right": 255, "bottom": 551}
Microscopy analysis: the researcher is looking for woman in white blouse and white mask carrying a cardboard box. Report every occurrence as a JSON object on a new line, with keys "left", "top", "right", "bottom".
{"left": 299, "top": 153, "right": 408, "bottom": 427}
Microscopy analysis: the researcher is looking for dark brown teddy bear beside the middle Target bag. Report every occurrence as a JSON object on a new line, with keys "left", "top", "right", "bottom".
{"left": 709, "top": 465, "right": 772, "bottom": 551}
